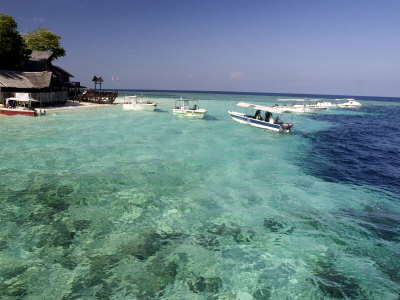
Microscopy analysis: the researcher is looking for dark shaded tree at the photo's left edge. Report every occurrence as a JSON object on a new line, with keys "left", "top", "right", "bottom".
{"left": 0, "top": 14, "right": 27, "bottom": 70}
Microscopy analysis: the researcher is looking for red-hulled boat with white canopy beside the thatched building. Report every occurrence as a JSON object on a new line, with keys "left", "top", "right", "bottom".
{"left": 0, "top": 93, "right": 46, "bottom": 117}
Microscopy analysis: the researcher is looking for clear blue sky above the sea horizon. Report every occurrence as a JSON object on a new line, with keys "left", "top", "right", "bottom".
{"left": 0, "top": 0, "right": 400, "bottom": 97}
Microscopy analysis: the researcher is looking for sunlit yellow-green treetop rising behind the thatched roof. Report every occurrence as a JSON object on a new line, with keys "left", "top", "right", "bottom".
{"left": 23, "top": 27, "right": 65, "bottom": 58}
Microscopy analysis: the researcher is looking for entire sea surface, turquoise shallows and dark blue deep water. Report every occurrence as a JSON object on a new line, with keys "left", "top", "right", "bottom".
{"left": 0, "top": 91, "right": 400, "bottom": 300}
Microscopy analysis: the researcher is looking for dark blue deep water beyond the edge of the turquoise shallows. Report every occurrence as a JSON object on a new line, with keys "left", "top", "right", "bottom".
{"left": 304, "top": 105, "right": 400, "bottom": 195}
